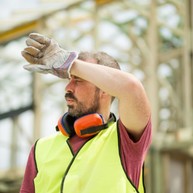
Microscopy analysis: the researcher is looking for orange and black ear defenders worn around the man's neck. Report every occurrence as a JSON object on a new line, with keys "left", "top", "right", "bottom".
{"left": 56, "top": 113, "right": 116, "bottom": 137}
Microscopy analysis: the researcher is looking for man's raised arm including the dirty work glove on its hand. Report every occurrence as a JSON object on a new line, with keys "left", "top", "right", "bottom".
{"left": 22, "top": 33, "right": 150, "bottom": 140}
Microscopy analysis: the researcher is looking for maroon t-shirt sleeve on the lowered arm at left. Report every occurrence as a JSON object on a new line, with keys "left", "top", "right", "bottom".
{"left": 20, "top": 146, "right": 37, "bottom": 193}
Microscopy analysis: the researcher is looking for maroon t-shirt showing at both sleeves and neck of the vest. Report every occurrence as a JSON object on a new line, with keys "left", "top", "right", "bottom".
{"left": 20, "top": 120, "right": 152, "bottom": 193}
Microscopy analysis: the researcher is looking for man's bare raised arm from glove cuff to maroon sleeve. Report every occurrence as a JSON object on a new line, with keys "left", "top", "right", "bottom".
{"left": 70, "top": 59, "right": 151, "bottom": 140}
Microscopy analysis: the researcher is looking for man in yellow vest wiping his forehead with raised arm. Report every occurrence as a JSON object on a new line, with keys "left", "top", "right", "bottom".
{"left": 20, "top": 33, "right": 151, "bottom": 193}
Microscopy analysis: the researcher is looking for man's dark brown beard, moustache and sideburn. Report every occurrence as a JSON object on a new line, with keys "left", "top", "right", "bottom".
{"left": 65, "top": 88, "right": 100, "bottom": 118}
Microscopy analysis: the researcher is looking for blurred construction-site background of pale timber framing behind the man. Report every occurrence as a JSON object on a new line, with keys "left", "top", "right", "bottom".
{"left": 0, "top": 0, "right": 193, "bottom": 193}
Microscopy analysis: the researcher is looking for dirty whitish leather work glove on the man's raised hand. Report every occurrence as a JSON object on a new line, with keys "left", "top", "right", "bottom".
{"left": 21, "top": 33, "right": 78, "bottom": 78}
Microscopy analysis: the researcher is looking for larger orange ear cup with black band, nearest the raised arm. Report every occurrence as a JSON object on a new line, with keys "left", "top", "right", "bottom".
{"left": 74, "top": 113, "right": 104, "bottom": 137}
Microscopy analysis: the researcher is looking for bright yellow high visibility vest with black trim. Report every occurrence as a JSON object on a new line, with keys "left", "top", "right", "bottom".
{"left": 34, "top": 123, "right": 144, "bottom": 193}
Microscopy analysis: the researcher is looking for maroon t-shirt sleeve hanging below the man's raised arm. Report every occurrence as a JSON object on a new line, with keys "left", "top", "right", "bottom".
{"left": 118, "top": 119, "right": 152, "bottom": 187}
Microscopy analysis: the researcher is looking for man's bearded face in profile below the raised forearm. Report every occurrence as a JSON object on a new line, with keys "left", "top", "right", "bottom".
{"left": 65, "top": 76, "right": 100, "bottom": 117}
